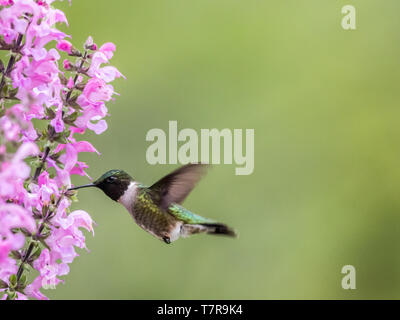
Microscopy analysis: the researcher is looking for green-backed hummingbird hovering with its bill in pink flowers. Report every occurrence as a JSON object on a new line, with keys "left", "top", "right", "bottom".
{"left": 69, "top": 164, "right": 236, "bottom": 244}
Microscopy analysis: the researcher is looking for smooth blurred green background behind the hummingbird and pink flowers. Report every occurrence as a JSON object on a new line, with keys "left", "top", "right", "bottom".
{"left": 46, "top": 0, "right": 400, "bottom": 299}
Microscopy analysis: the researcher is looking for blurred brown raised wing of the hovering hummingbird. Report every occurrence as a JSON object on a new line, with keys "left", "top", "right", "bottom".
{"left": 149, "top": 163, "right": 209, "bottom": 210}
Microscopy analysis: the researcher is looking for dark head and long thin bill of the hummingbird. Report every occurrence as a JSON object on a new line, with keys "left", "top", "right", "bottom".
{"left": 69, "top": 170, "right": 133, "bottom": 201}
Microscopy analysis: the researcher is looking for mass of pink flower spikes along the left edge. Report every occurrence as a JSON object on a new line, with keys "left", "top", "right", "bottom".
{"left": 0, "top": 6, "right": 124, "bottom": 300}
